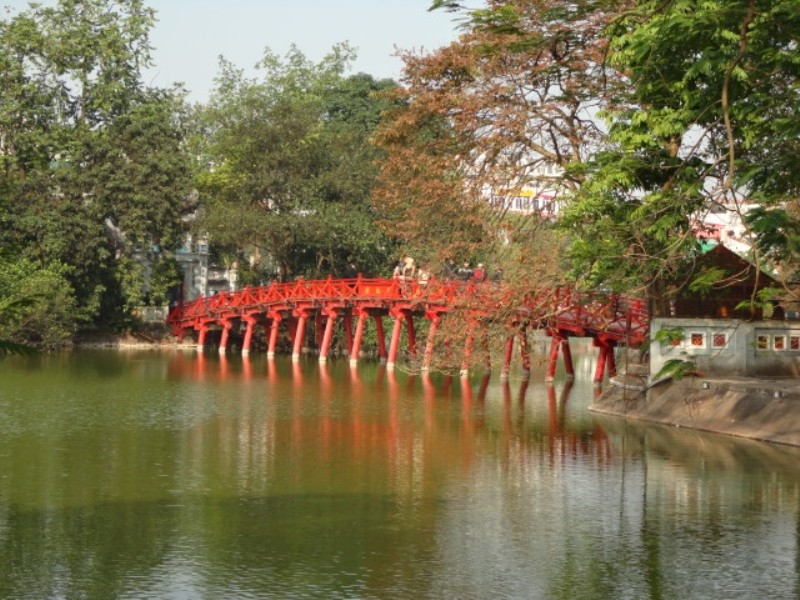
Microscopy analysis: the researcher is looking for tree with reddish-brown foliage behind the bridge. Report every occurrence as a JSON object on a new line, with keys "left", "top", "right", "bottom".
{"left": 376, "top": 0, "right": 621, "bottom": 274}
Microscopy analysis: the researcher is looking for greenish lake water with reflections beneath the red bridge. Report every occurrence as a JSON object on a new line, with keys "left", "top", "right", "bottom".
{"left": 0, "top": 350, "right": 800, "bottom": 599}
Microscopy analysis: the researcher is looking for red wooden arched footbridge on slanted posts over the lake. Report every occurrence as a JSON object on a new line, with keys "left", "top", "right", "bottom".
{"left": 168, "top": 277, "right": 649, "bottom": 382}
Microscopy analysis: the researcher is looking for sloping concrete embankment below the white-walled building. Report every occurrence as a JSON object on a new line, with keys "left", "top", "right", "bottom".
{"left": 589, "top": 375, "right": 800, "bottom": 446}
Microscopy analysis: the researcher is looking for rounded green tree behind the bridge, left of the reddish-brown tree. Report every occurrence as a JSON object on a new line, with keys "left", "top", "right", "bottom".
{"left": 199, "top": 44, "right": 394, "bottom": 279}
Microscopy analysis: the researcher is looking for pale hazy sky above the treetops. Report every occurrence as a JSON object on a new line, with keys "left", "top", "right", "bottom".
{"left": 0, "top": 0, "right": 466, "bottom": 102}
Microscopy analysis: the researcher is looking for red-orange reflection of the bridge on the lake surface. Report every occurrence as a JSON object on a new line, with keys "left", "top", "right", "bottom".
{"left": 169, "top": 353, "right": 612, "bottom": 464}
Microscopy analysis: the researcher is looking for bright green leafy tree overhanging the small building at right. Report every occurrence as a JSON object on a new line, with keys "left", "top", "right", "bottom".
{"left": 563, "top": 0, "right": 800, "bottom": 309}
